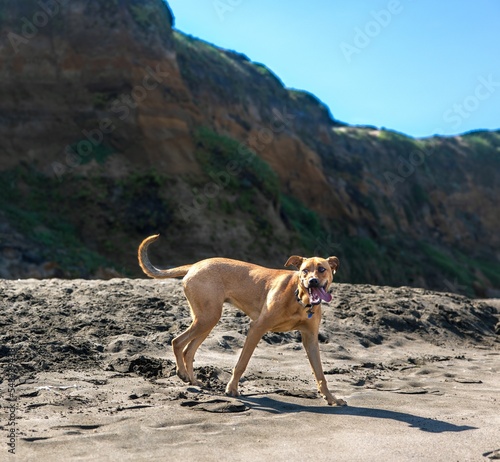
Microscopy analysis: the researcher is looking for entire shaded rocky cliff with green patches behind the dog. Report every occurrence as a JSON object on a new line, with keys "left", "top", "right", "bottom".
{"left": 0, "top": 0, "right": 500, "bottom": 295}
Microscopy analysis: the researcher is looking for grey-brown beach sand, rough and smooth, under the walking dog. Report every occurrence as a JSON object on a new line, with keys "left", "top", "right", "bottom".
{"left": 0, "top": 279, "right": 500, "bottom": 462}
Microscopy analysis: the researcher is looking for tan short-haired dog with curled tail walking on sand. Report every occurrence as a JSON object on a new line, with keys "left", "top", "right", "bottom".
{"left": 138, "top": 235, "right": 346, "bottom": 406}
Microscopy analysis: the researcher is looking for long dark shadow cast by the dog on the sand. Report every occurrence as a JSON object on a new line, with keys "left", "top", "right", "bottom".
{"left": 238, "top": 395, "right": 477, "bottom": 433}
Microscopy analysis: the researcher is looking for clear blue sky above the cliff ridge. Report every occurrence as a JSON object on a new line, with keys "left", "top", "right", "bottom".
{"left": 168, "top": 0, "right": 500, "bottom": 137}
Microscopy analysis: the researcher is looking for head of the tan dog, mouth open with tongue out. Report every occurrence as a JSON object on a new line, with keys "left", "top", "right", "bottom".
{"left": 285, "top": 255, "right": 340, "bottom": 305}
